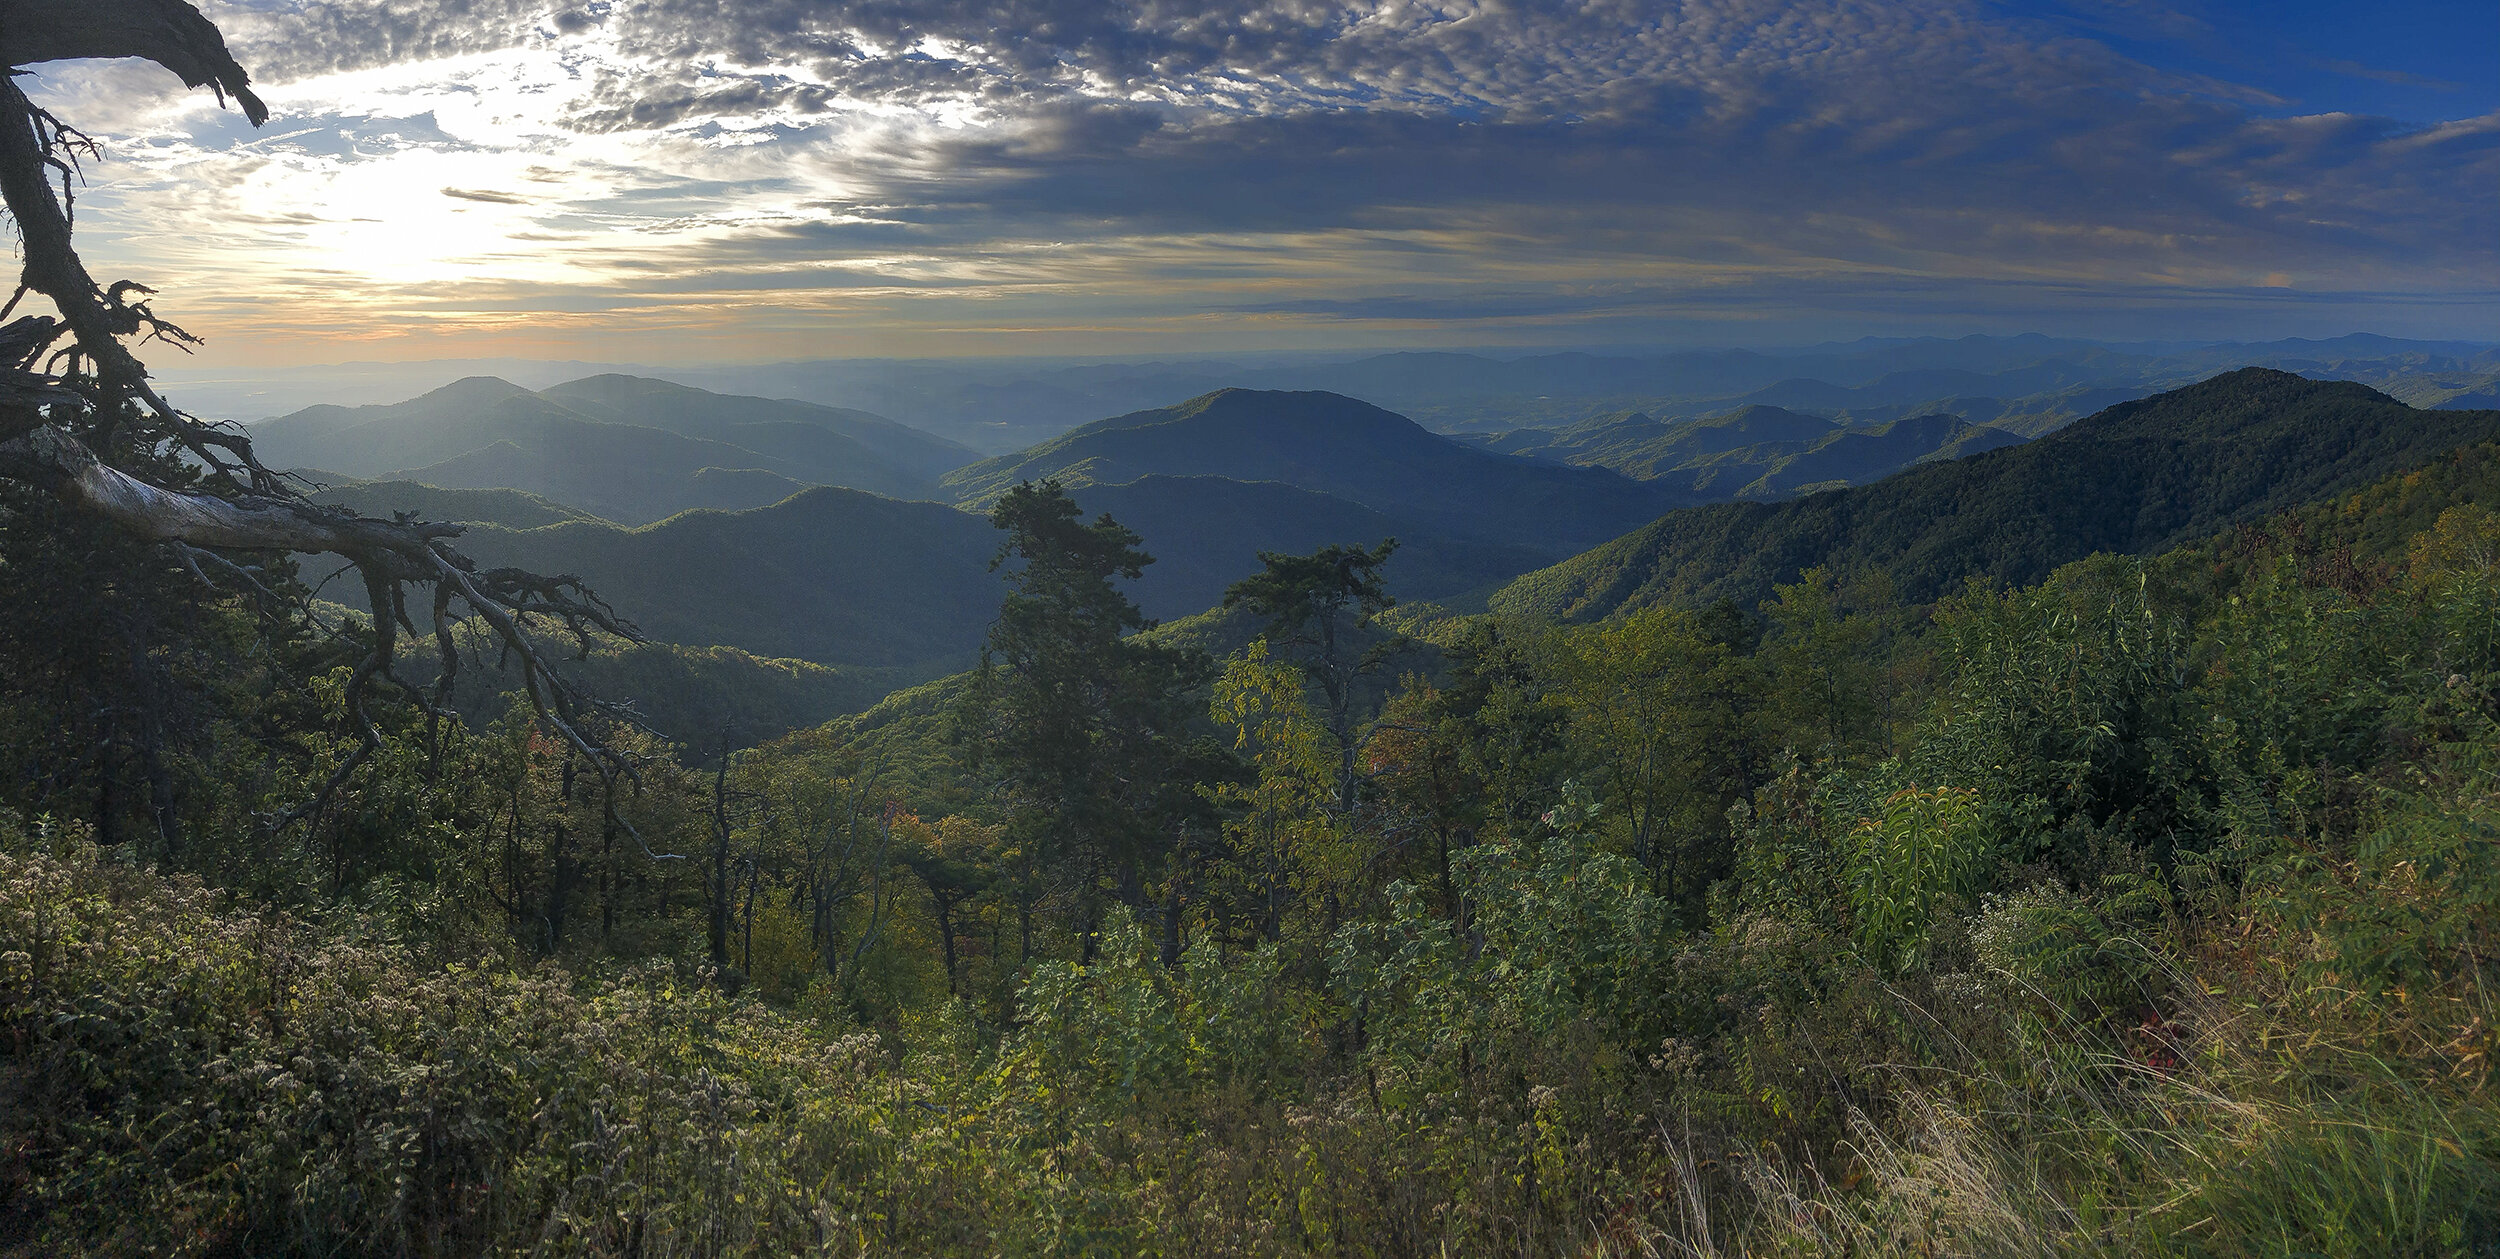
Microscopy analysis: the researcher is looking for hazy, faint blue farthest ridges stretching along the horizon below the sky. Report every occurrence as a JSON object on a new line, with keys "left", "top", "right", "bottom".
{"left": 185, "top": 332, "right": 2500, "bottom": 467}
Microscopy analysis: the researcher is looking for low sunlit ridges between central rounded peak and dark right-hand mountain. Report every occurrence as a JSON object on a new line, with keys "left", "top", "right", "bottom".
{"left": 1483, "top": 405, "right": 2023, "bottom": 497}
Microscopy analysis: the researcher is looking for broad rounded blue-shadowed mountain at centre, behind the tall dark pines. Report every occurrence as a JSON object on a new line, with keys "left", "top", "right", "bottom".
{"left": 945, "top": 390, "right": 1690, "bottom": 555}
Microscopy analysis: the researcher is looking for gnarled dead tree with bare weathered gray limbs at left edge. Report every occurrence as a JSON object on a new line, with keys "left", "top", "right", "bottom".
{"left": 0, "top": 0, "right": 640, "bottom": 824}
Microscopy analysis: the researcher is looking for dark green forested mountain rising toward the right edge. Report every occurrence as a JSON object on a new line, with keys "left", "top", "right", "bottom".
{"left": 1493, "top": 367, "right": 2500, "bottom": 620}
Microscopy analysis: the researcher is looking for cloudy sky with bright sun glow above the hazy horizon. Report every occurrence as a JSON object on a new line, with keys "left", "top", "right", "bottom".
{"left": 30, "top": 0, "right": 2500, "bottom": 367}
